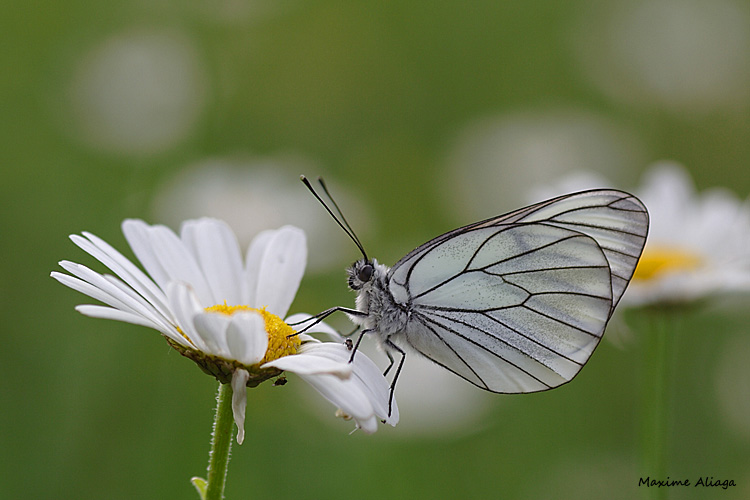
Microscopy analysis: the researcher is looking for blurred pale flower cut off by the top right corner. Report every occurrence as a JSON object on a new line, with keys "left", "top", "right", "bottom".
{"left": 571, "top": 0, "right": 750, "bottom": 113}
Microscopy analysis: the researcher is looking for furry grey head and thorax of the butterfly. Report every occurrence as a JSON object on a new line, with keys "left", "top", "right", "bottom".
{"left": 349, "top": 259, "right": 409, "bottom": 342}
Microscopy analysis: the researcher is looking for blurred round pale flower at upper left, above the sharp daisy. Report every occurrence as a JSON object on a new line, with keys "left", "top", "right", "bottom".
{"left": 69, "top": 28, "right": 208, "bottom": 156}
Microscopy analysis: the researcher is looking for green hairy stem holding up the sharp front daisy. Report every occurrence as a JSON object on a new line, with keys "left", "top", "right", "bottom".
{"left": 206, "top": 383, "right": 234, "bottom": 500}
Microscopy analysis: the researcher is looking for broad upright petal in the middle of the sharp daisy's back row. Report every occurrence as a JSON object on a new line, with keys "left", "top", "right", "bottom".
{"left": 180, "top": 218, "right": 244, "bottom": 305}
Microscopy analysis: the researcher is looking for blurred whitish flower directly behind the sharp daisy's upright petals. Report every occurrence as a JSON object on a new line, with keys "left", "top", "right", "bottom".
{"left": 152, "top": 156, "right": 371, "bottom": 272}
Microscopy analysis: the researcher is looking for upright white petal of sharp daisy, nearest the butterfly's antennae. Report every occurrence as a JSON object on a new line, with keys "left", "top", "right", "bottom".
{"left": 248, "top": 226, "right": 307, "bottom": 317}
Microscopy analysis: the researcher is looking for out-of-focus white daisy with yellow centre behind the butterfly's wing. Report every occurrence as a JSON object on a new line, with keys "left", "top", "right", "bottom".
{"left": 529, "top": 161, "right": 750, "bottom": 306}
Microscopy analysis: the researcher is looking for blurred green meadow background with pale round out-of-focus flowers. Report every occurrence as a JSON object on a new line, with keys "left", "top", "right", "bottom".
{"left": 0, "top": 0, "right": 750, "bottom": 499}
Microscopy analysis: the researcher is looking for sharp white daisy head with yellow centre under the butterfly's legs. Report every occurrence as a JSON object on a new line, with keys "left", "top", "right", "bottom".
{"left": 52, "top": 218, "right": 398, "bottom": 443}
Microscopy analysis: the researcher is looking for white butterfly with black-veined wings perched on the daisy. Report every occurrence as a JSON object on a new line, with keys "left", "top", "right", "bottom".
{"left": 296, "top": 179, "right": 649, "bottom": 412}
